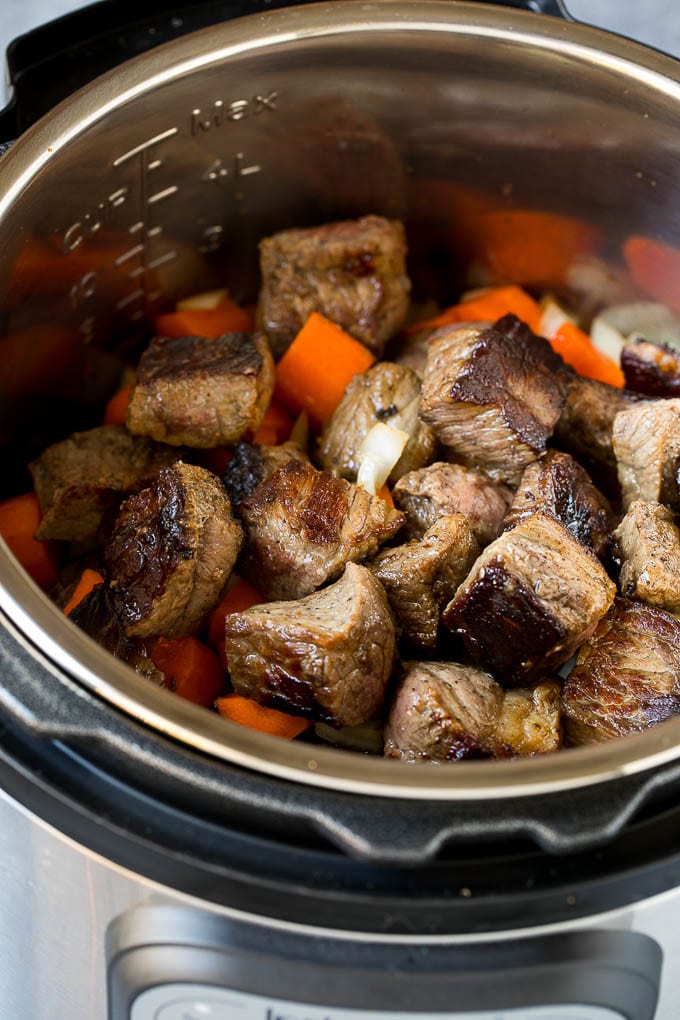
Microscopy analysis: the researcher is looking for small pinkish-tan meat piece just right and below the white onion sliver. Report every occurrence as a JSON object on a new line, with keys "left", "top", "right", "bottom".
{"left": 391, "top": 462, "right": 512, "bottom": 546}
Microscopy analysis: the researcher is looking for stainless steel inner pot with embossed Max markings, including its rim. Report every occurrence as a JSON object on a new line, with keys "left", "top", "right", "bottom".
{"left": 0, "top": 0, "right": 680, "bottom": 800}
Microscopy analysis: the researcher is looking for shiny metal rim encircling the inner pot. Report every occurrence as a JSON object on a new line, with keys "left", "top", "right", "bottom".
{"left": 0, "top": 0, "right": 680, "bottom": 801}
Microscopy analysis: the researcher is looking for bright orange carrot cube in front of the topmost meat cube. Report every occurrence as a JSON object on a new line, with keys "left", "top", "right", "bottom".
{"left": 275, "top": 312, "right": 375, "bottom": 427}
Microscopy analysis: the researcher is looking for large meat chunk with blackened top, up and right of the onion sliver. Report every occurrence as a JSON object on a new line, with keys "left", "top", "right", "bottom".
{"left": 420, "top": 316, "right": 566, "bottom": 485}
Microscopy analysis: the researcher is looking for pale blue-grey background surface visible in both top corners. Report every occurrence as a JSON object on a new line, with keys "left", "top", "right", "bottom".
{"left": 0, "top": 0, "right": 680, "bottom": 105}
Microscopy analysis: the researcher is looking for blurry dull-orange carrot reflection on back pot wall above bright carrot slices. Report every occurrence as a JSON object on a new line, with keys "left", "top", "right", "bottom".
{"left": 475, "top": 209, "right": 601, "bottom": 290}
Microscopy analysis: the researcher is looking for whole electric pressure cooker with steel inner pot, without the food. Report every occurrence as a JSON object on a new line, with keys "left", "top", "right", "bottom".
{"left": 0, "top": 0, "right": 680, "bottom": 1020}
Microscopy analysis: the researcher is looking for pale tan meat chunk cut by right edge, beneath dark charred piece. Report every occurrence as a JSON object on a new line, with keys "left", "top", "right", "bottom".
{"left": 613, "top": 398, "right": 680, "bottom": 510}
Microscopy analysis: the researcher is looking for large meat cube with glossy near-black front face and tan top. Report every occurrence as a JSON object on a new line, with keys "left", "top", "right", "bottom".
{"left": 443, "top": 514, "right": 616, "bottom": 684}
